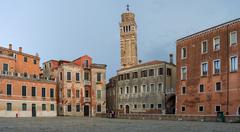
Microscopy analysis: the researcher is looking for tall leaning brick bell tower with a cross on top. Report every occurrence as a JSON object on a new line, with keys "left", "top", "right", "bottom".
{"left": 120, "top": 5, "right": 138, "bottom": 68}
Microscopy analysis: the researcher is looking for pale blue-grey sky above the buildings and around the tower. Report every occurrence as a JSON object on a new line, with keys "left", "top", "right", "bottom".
{"left": 0, "top": 0, "right": 240, "bottom": 78}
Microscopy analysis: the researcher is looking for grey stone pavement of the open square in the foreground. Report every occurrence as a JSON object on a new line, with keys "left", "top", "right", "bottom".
{"left": 0, "top": 117, "right": 240, "bottom": 132}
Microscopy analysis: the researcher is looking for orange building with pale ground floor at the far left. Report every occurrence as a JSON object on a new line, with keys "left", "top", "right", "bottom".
{"left": 0, "top": 44, "right": 57, "bottom": 117}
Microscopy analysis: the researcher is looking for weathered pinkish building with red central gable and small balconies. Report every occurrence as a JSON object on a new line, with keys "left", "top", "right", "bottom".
{"left": 43, "top": 55, "right": 106, "bottom": 116}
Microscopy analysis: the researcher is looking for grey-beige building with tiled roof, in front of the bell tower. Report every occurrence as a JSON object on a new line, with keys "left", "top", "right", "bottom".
{"left": 116, "top": 61, "right": 176, "bottom": 114}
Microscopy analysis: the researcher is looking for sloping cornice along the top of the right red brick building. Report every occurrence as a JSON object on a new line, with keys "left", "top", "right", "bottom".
{"left": 177, "top": 18, "right": 240, "bottom": 42}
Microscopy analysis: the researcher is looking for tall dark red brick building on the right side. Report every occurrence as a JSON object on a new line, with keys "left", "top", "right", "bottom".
{"left": 176, "top": 19, "right": 240, "bottom": 115}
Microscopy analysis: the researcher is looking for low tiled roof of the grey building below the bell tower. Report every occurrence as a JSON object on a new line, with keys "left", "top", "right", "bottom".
{"left": 118, "top": 60, "right": 175, "bottom": 71}
